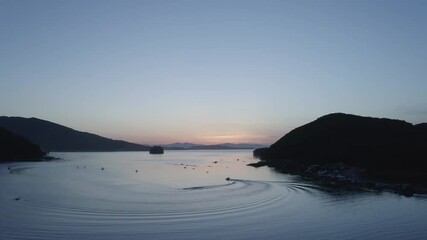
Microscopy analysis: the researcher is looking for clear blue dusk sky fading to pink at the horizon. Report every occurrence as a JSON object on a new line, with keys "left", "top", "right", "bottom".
{"left": 0, "top": 0, "right": 427, "bottom": 144}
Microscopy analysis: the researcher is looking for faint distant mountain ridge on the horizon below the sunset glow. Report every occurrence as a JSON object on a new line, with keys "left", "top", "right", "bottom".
{"left": 163, "top": 142, "right": 266, "bottom": 150}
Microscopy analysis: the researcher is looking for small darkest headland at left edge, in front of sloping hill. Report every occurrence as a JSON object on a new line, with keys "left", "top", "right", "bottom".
{"left": 0, "top": 128, "right": 46, "bottom": 162}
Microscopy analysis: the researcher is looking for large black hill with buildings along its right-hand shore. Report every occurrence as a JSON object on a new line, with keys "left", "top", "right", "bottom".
{"left": 252, "top": 113, "right": 427, "bottom": 195}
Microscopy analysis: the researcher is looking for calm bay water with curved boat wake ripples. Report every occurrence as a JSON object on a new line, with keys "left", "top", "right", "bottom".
{"left": 0, "top": 150, "right": 427, "bottom": 239}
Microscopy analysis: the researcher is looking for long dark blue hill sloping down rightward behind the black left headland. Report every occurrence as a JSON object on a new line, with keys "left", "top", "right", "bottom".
{"left": 0, "top": 117, "right": 150, "bottom": 152}
